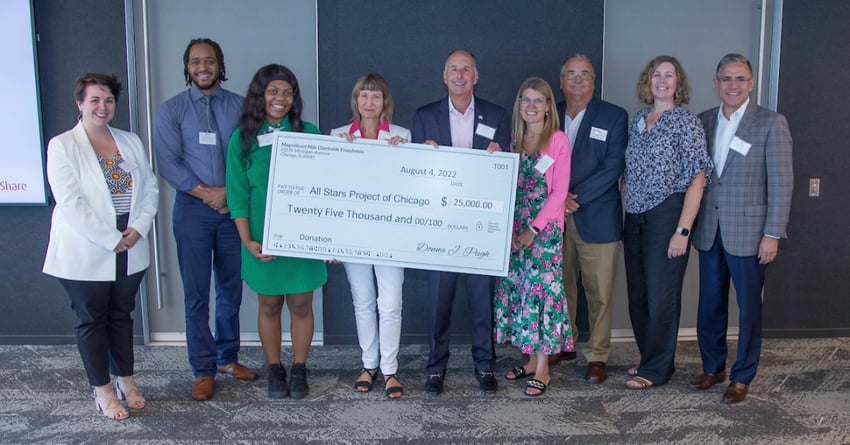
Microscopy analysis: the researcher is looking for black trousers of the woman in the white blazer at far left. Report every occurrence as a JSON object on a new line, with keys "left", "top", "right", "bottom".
{"left": 59, "top": 215, "right": 145, "bottom": 386}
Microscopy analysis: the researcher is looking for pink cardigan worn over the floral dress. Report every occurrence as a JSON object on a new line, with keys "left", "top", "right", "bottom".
{"left": 512, "top": 130, "right": 571, "bottom": 231}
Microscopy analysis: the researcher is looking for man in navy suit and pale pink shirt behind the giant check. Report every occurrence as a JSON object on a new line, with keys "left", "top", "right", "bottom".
{"left": 412, "top": 49, "right": 511, "bottom": 394}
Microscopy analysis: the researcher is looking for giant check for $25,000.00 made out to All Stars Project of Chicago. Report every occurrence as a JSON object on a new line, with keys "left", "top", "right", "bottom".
{"left": 263, "top": 132, "right": 518, "bottom": 276}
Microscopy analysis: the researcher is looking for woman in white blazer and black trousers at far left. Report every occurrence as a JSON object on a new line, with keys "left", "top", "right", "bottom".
{"left": 43, "top": 74, "right": 159, "bottom": 420}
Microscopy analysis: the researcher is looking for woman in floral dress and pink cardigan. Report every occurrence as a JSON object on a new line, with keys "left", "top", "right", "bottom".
{"left": 494, "top": 78, "right": 573, "bottom": 396}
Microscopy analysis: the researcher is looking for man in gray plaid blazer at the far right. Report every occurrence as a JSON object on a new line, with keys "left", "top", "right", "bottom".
{"left": 691, "top": 54, "right": 794, "bottom": 404}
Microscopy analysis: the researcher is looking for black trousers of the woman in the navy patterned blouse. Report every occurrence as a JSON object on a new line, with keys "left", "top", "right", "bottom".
{"left": 623, "top": 193, "right": 690, "bottom": 385}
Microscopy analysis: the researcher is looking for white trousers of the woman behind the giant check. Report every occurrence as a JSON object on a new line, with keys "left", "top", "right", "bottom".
{"left": 344, "top": 263, "right": 404, "bottom": 375}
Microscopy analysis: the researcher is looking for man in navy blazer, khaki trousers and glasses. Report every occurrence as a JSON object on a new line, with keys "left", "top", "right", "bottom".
{"left": 558, "top": 54, "right": 628, "bottom": 383}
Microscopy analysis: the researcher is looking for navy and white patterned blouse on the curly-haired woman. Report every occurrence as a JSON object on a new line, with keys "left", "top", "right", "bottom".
{"left": 624, "top": 106, "right": 714, "bottom": 213}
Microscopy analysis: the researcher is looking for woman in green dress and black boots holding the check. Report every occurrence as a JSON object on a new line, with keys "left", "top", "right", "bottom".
{"left": 227, "top": 65, "right": 327, "bottom": 399}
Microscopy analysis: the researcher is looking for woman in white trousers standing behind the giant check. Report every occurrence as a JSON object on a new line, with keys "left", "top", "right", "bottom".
{"left": 331, "top": 73, "right": 410, "bottom": 399}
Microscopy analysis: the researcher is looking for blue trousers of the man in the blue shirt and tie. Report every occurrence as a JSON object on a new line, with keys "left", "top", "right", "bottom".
{"left": 173, "top": 192, "right": 242, "bottom": 377}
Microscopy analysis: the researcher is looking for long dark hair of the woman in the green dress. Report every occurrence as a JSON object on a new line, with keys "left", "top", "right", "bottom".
{"left": 239, "top": 64, "right": 304, "bottom": 158}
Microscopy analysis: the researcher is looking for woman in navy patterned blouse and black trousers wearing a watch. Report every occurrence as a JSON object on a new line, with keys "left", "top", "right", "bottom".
{"left": 623, "top": 56, "right": 713, "bottom": 389}
